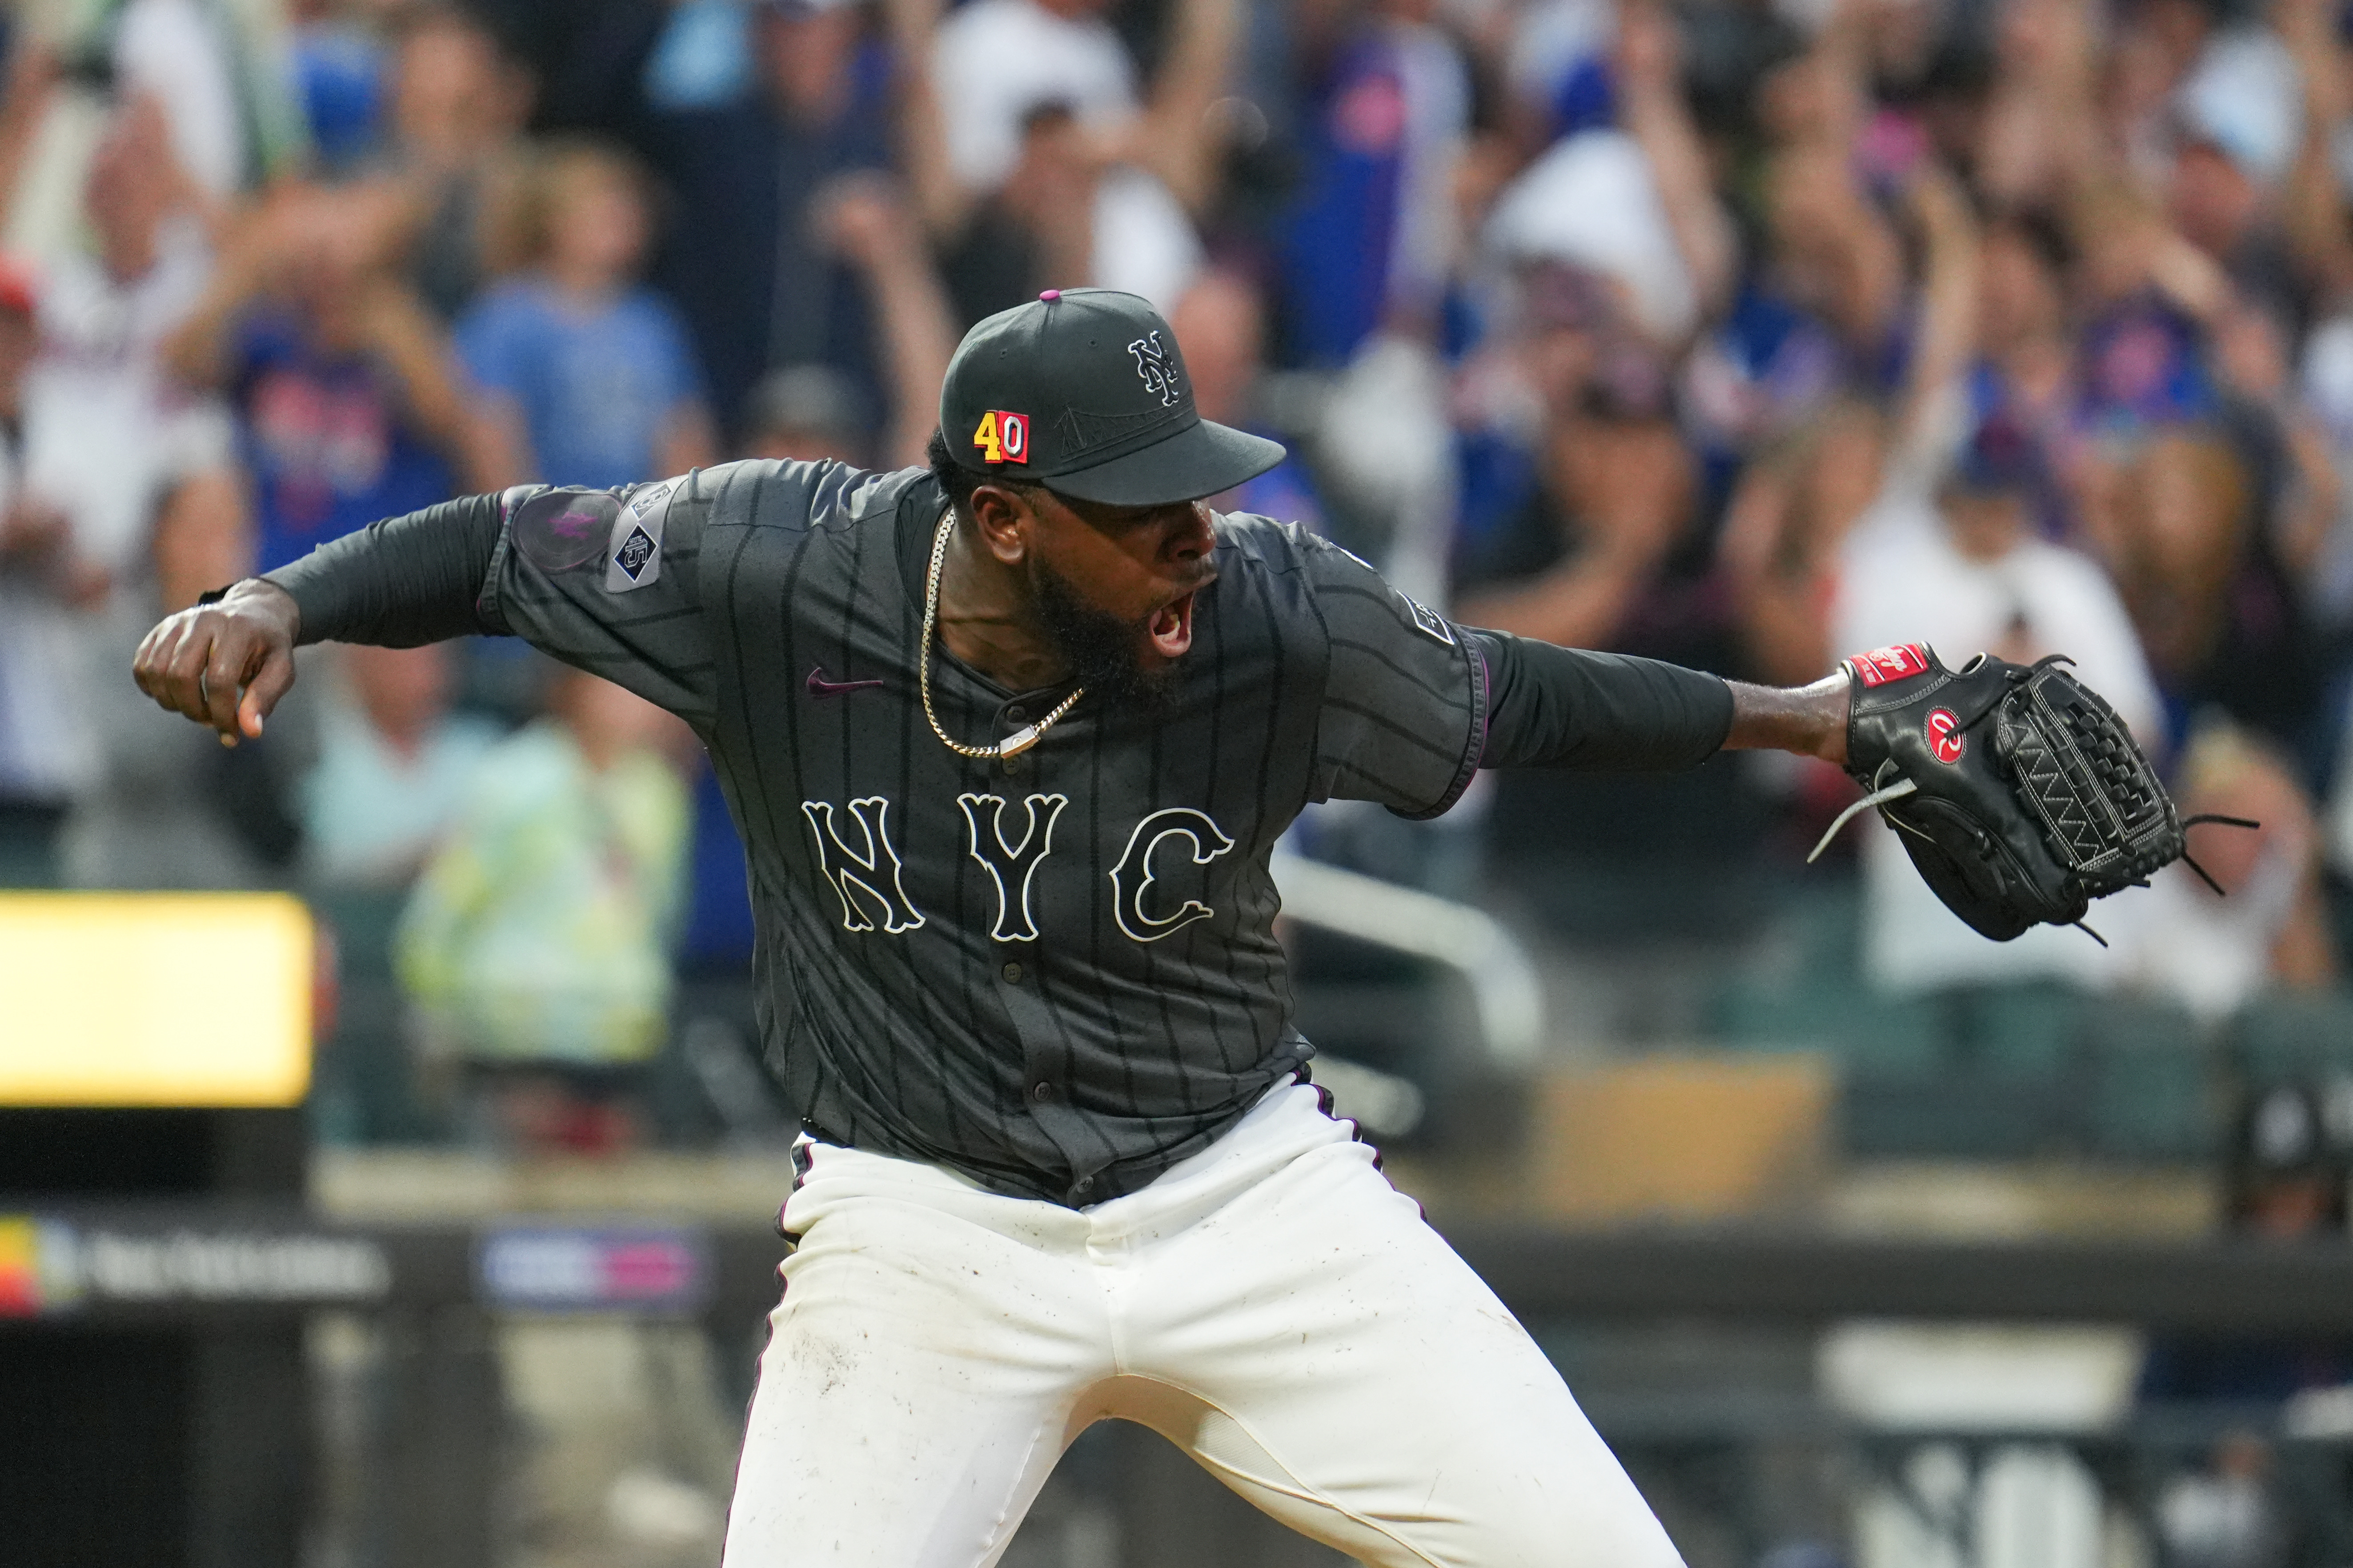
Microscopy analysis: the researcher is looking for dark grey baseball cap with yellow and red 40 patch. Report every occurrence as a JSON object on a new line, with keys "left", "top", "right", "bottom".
{"left": 939, "top": 289, "right": 1283, "bottom": 505}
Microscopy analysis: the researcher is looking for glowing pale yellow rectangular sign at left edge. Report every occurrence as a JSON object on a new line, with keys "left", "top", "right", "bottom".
{"left": 0, "top": 893, "right": 313, "bottom": 1105}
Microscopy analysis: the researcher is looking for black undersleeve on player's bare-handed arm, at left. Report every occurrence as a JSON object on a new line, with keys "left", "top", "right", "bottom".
{"left": 261, "top": 484, "right": 506, "bottom": 649}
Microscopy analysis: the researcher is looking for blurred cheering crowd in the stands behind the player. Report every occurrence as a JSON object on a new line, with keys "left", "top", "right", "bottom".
{"left": 0, "top": 0, "right": 2353, "bottom": 1147}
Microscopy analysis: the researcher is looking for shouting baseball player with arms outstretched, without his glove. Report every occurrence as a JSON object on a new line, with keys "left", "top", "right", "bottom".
{"left": 136, "top": 289, "right": 1849, "bottom": 1568}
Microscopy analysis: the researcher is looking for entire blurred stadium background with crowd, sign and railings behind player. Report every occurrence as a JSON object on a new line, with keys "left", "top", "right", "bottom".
{"left": 0, "top": 0, "right": 2353, "bottom": 1568}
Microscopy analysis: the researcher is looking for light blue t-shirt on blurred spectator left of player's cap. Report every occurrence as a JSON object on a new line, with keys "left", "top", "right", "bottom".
{"left": 457, "top": 277, "right": 701, "bottom": 489}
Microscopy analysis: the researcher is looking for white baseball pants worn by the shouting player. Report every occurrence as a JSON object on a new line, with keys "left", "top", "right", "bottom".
{"left": 725, "top": 1084, "right": 1682, "bottom": 1568}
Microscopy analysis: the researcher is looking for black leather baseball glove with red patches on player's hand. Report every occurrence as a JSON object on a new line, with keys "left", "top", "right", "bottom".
{"left": 1807, "top": 642, "right": 2254, "bottom": 945}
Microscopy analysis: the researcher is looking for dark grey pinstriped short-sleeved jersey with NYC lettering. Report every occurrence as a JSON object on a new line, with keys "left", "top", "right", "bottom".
{"left": 480, "top": 463, "right": 1487, "bottom": 1206}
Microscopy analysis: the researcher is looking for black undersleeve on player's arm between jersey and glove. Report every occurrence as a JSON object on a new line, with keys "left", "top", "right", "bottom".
{"left": 1466, "top": 628, "right": 1736, "bottom": 773}
